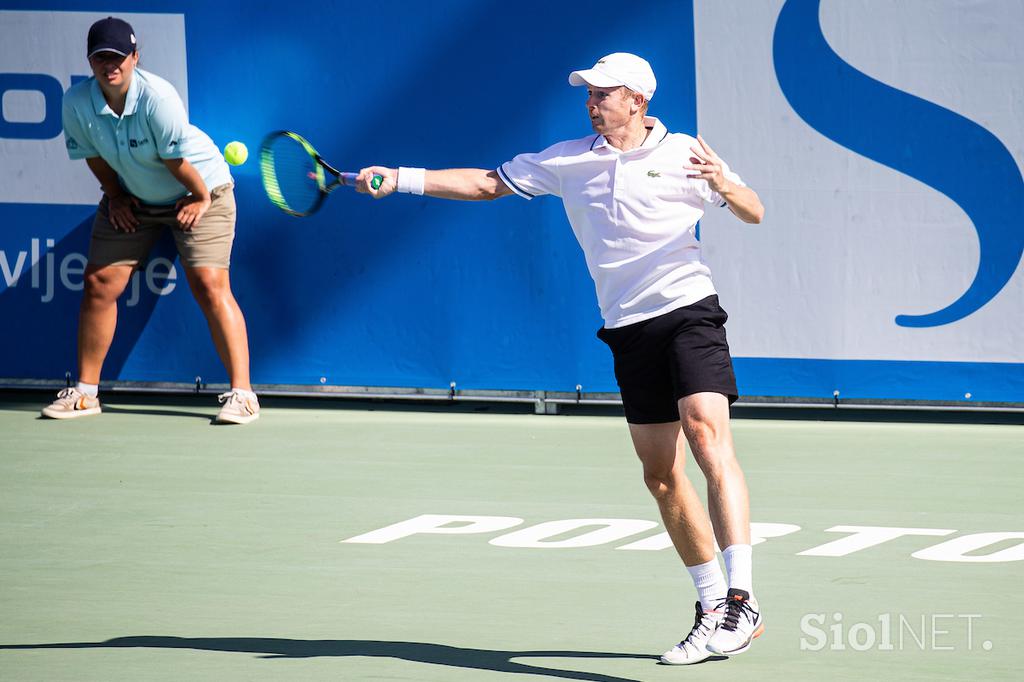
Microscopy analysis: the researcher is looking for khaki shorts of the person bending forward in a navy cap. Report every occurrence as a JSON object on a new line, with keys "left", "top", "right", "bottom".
{"left": 89, "top": 183, "right": 234, "bottom": 269}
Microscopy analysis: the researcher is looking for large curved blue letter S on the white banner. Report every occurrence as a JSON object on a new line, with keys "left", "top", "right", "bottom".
{"left": 772, "top": 0, "right": 1024, "bottom": 327}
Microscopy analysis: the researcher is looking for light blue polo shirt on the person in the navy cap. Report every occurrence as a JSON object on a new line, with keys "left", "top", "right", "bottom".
{"left": 63, "top": 69, "right": 231, "bottom": 204}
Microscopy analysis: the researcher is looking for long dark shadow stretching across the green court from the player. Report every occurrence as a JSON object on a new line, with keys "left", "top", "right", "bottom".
{"left": 0, "top": 635, "right": 671, "bottom": 682}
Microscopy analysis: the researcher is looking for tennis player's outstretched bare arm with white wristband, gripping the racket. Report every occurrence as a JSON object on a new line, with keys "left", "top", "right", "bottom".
{"left": 355, "top": 166, "right": 512, "bottom": 202}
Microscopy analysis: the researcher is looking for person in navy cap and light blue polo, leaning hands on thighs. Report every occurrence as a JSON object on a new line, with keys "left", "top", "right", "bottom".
{"left": 43, "top": 16, "right": 259, "bottom": 424}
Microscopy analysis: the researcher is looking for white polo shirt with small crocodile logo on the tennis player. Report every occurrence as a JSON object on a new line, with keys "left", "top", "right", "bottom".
{"left": 498, "top": 117, "right": 745, "bottom": 329}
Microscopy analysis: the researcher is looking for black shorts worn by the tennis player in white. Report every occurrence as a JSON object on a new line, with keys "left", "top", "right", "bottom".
{"left": 597, "top": 295, "right": 737, "bottom": 424}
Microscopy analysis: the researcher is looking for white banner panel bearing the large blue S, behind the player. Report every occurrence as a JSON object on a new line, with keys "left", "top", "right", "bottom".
{"left": 696, "top": 0, "right": 1024, "bottom": 363}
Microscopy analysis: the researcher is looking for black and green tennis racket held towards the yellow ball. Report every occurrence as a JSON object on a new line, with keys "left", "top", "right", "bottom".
{"left": 259, "top": 130, "right": 384, "bottom": 217}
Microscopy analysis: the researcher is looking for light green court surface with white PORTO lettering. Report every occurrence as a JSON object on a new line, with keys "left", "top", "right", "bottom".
{"left": 0, "top": 394, "right": 1024, "bottom": 682}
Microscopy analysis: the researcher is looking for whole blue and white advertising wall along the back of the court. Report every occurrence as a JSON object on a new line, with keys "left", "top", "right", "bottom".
{"left": 0, "top": 0, "right": 1024, "bottom": 402}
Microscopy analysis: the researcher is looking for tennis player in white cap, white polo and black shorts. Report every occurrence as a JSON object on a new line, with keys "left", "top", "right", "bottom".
{"left": 358, "top": 52, "right": 764, "bottom": 664}
